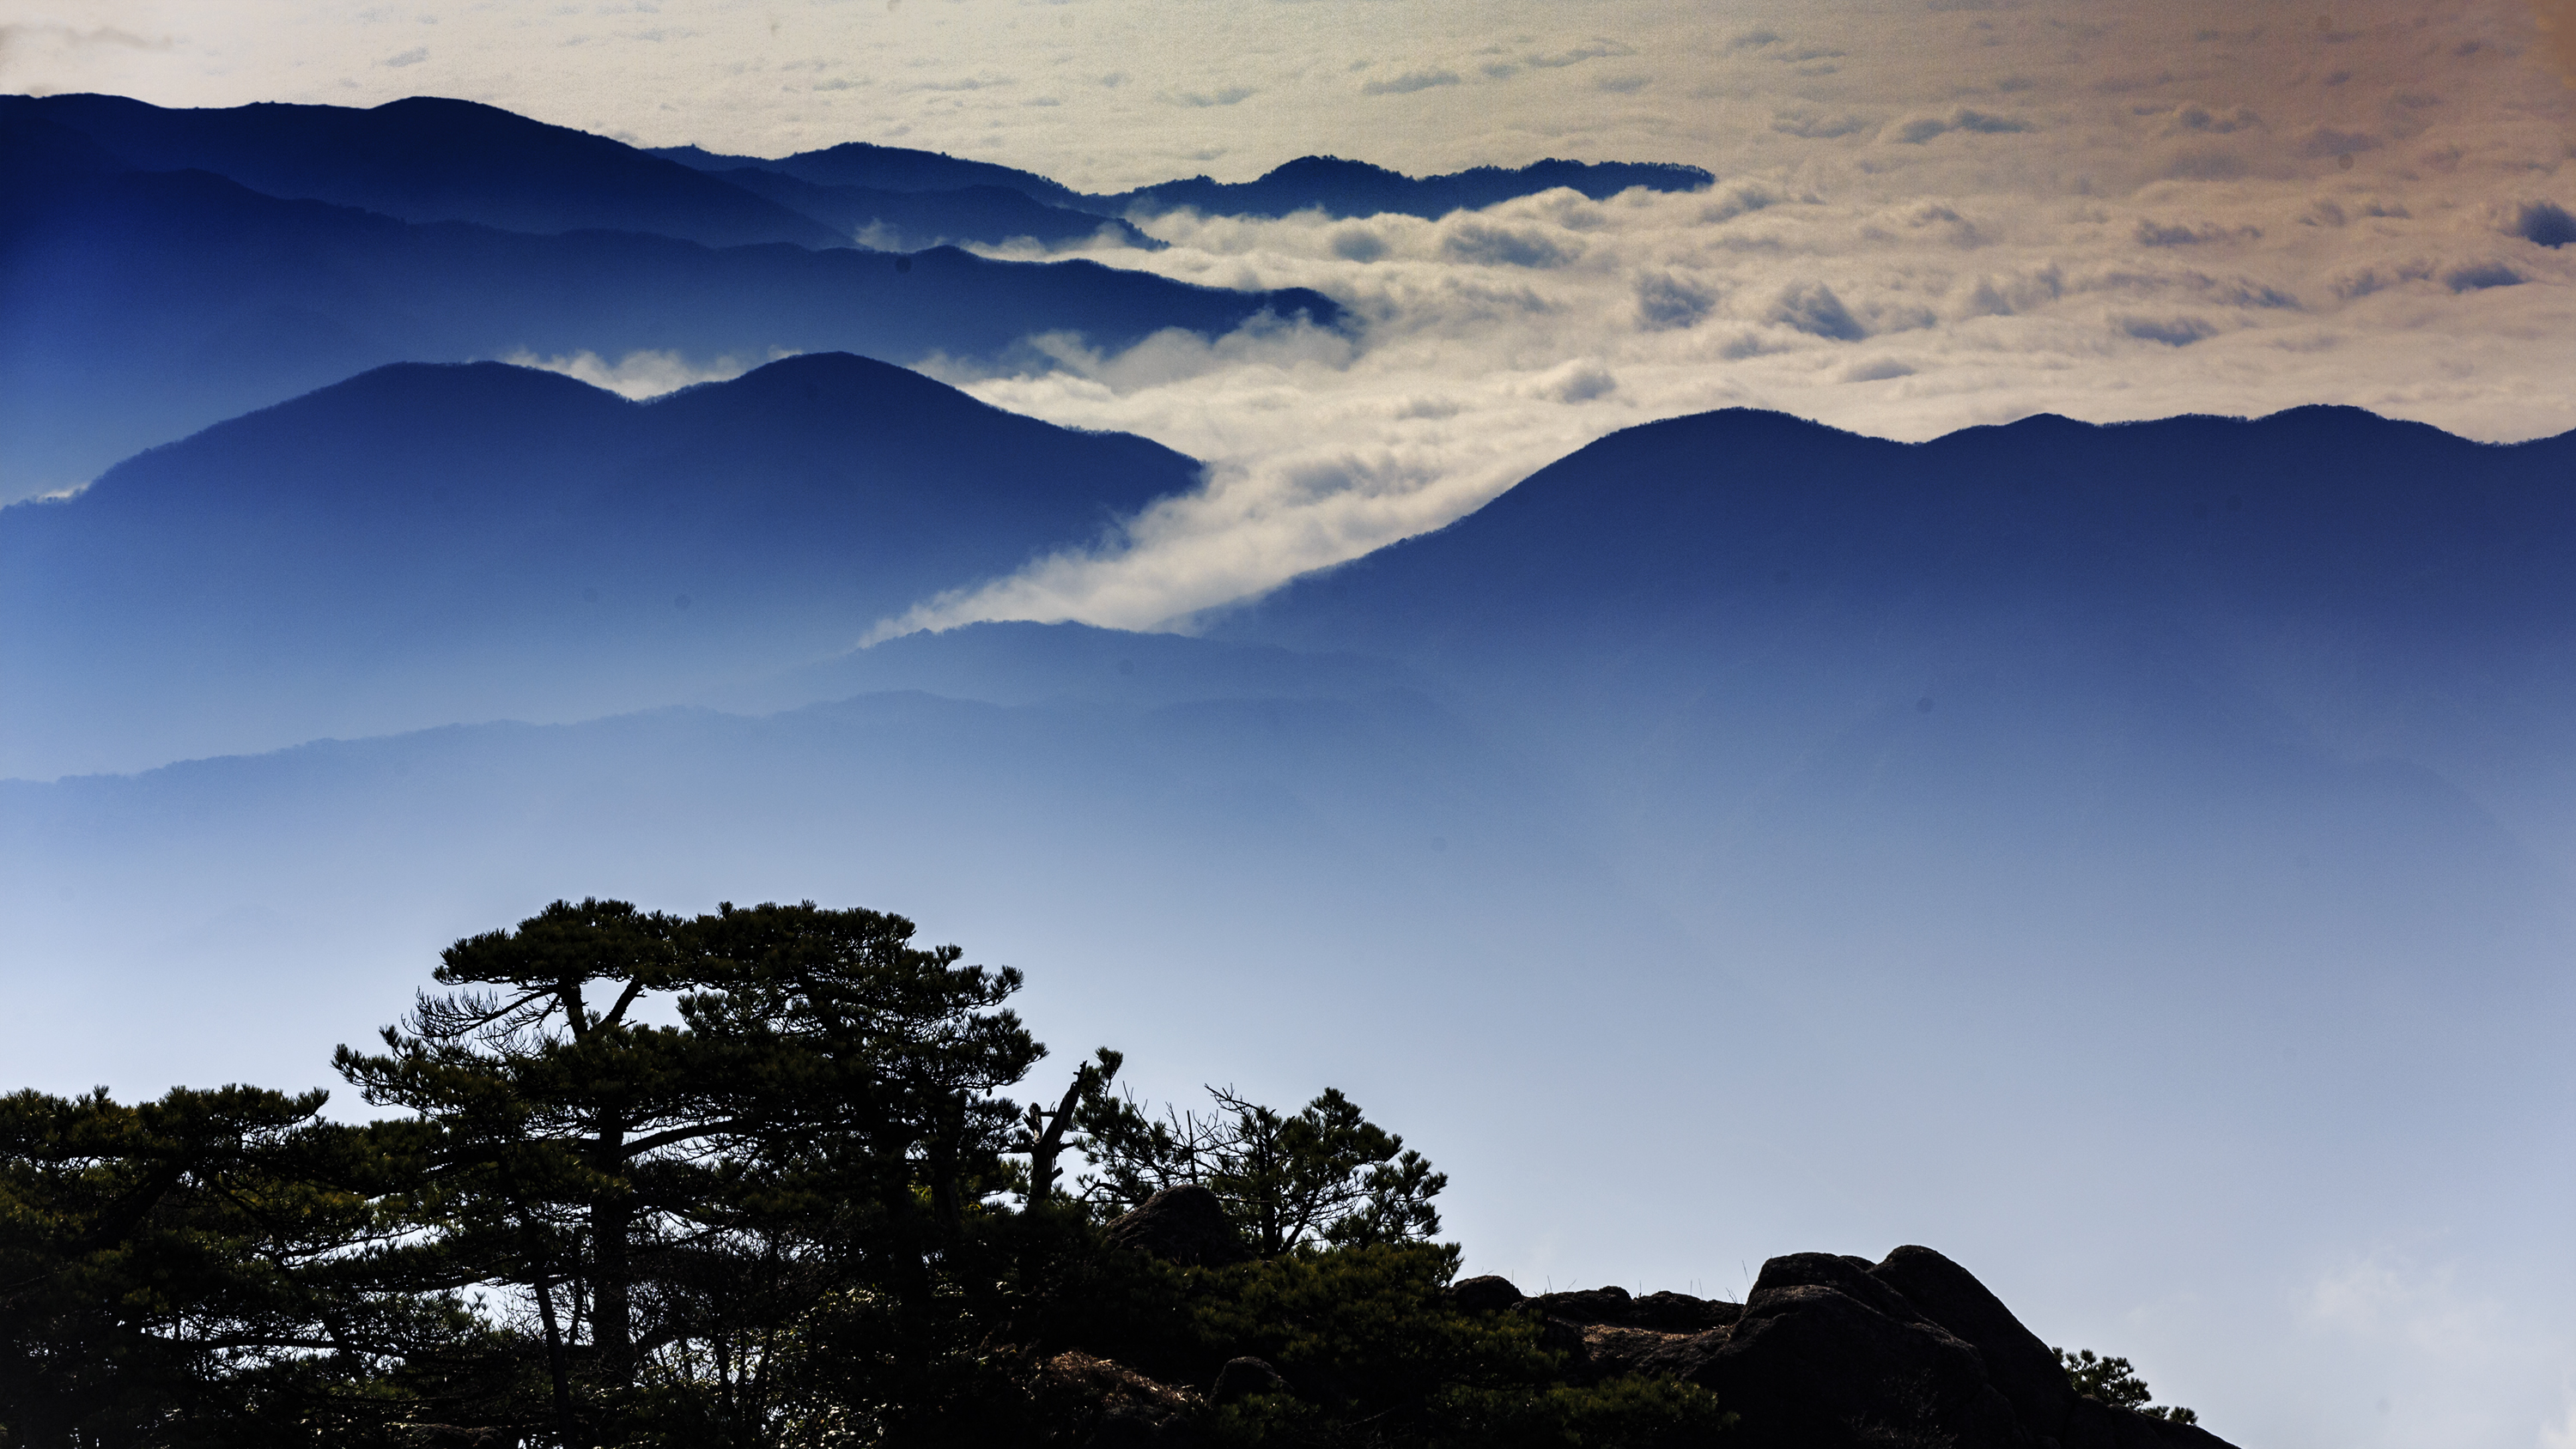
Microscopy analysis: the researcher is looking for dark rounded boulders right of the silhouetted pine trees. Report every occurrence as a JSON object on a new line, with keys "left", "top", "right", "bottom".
{"left": 1453, "top": 1246, "right": 2228, "bottom": 1449}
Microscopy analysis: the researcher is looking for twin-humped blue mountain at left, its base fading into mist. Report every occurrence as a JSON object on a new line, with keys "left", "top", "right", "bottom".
{"left": 0, "top": 355, "right": 1198, "bottom": 774}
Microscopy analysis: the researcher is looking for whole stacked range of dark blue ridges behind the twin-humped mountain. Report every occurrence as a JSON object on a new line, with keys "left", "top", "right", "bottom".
{"left": 0, "top": 95, "right": 1708, "bottom": 502}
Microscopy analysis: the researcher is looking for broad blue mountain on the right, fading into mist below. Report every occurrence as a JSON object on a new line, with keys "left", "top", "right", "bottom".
{"left": 1213, "top": 409, "right": 2576, "bottom": 890}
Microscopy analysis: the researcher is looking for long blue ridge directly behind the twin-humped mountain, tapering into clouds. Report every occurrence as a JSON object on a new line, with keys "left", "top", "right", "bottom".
{"left": 0, "top": 162, "right": 1340, "bottom": 497}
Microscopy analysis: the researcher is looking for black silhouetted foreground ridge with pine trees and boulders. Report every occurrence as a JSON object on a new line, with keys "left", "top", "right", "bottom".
{"left": 0, "top": 890, "right": 2226, "bottom": 1449}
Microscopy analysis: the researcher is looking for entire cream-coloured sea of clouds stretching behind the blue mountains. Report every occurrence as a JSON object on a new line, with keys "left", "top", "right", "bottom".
{"left": 0, "top": 0, "right": 2576, "bottom": 628}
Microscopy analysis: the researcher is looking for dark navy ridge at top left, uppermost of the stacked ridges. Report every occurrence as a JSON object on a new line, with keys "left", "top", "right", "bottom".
{"left": 0, "top": 95, "right": 848, "bottom": 247}
